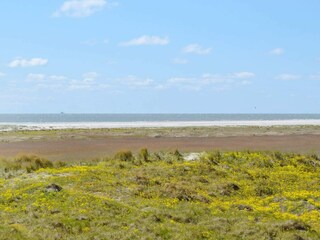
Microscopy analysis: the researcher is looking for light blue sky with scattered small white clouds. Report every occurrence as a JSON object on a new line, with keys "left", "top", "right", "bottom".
{"left": 0, "top": 0, "right": 320, "bottom": 113}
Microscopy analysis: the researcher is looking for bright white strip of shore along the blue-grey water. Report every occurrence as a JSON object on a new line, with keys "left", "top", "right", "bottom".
{"left": 0, "top": 119, "right": 320, "bottom": 131}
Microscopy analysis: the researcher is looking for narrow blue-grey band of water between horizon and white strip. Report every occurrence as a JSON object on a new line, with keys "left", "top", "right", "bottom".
{"left": 0, "top": 114, "right": 320, "bottom": 124}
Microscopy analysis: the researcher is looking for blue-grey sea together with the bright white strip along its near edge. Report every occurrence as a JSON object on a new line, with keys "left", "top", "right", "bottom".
{"left": 0, "top": 113, "right": 320, "bottom": 131}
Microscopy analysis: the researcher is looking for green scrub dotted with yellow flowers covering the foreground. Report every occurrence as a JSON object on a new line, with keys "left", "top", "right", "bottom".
{"left": 0, "top": 149, "right": 320, "bottom": 240}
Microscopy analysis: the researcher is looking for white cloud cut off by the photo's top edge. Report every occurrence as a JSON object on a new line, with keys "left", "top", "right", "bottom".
{"left": 53, "top": 0, "right": 107, "bottom": 17}
